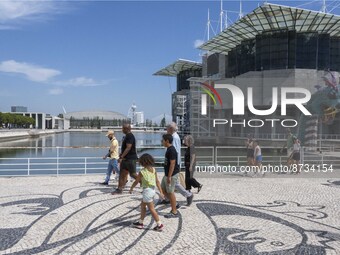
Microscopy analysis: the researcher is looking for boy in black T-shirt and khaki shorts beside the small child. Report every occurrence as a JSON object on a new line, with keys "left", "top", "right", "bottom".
{"left": 161, "top": 134, "right": 179, "bottom": 218}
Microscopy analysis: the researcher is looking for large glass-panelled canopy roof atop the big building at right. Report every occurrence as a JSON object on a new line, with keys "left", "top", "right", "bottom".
{"left": 199, "top": 4, "right": 340, "bottom": 55}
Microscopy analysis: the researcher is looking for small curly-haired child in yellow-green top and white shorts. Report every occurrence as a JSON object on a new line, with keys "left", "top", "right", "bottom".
{"left": 130, "top": 153, "right": 164, "bottom": 231}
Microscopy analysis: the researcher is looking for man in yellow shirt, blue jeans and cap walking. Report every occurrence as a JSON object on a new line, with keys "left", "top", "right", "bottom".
{"left": 101, "top": 130, "right": 119, "bottom": 185}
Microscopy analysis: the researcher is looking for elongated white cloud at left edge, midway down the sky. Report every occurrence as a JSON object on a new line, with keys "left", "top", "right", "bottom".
{"left": 0, "top": 60, "right": 61, "bottom": 82}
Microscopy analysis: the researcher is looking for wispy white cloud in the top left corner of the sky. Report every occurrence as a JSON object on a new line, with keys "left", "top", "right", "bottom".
{"left": 0, "top": 0, "right": 66, "bottom": 29}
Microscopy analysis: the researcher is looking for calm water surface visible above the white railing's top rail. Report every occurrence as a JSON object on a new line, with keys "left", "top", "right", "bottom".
{"left": 0, "top": 132, "right": 162, "bottom": 160}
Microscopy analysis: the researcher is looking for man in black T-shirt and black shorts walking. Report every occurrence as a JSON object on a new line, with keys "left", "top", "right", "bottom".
{"left": 111, "top": 124, "right": 138, "bottom": 195}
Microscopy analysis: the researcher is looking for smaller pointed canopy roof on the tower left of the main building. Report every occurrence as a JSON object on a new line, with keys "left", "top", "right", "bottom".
{"left": 153, "top": 59, "right": 202, "bottom": 76}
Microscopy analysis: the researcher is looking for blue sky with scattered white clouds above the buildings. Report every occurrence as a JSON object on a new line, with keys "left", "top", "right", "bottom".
{"left": 0, "top": 0, "right": 340, "bottom": 119}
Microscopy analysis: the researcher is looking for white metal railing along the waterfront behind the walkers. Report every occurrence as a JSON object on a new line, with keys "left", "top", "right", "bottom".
{"left": 0, "top": 146, "right": 340, "bottom": 176}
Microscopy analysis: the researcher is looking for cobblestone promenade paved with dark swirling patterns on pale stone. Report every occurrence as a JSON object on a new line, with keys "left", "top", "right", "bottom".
{"left": 0, "top": 173, "right": 340, "bottom": 255}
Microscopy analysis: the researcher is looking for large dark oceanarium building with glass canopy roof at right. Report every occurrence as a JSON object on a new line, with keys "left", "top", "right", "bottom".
{"left": 156, "top": 4, "right": 340, "bottom": 143}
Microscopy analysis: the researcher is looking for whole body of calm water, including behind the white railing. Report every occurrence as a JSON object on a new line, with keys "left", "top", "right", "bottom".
{"left": 0, "top": 132, "right": 164, "bottom": 175}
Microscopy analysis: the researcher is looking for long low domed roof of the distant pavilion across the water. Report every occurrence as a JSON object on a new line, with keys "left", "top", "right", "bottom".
{"left": 64, "top": 110, "right": 127, "bottom": 120}
